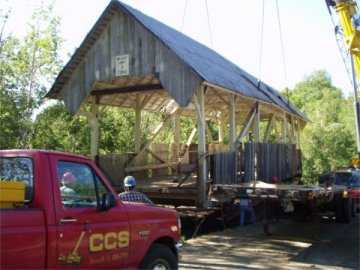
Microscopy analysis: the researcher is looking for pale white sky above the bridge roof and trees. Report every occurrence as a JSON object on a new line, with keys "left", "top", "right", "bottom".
{"left": 0, "top": 0, "right": 352, "bottom": 95}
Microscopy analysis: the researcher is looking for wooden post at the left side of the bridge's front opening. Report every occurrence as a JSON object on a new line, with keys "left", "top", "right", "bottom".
{"left": 87, "top": 97, "right": 100, "bottom": 160}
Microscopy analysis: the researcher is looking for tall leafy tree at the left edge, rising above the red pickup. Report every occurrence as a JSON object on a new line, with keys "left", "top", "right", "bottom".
{"left": 0, "top": 1, "right": 62, "bottom": 148}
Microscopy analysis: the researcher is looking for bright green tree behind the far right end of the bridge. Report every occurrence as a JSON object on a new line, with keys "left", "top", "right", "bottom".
{"left": 290, "top": 71, "right": 356, "bottom": 182}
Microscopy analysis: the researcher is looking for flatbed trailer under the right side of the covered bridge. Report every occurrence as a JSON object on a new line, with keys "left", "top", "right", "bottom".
{"left": 213, "top": 181, "right": 355, "bottom": 223}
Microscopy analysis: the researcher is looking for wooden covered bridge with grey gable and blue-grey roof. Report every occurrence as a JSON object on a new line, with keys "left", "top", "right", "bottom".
{"left": 47, "top": 1, "right": 307, "bottom": 208}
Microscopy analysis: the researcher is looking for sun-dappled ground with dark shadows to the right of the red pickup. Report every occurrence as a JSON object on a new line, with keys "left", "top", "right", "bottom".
{"left": 180, "top": 215, "right": 360, "bottom": 270}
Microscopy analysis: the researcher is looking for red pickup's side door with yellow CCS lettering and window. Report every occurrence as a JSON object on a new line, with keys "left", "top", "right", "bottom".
{"left": 51, "top": 157, "right": 130, "bottom": 269}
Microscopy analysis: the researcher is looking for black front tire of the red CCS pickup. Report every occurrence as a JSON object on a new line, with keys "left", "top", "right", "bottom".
{"left": 140, "top": 244, "right": 178, "bottom": 270}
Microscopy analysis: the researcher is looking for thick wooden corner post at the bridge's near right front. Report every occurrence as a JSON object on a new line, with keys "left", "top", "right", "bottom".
{"left": 194, "top": 86, "right": 208, "bottom": 209}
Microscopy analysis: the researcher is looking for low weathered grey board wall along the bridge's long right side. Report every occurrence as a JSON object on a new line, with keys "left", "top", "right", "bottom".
{"left": 210, "top": 142, "right": 301, "bottom": 184}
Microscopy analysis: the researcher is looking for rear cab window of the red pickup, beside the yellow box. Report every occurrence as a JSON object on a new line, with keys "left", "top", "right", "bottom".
{"left": 0, "top": 157, "right": 34, "bottom": 202}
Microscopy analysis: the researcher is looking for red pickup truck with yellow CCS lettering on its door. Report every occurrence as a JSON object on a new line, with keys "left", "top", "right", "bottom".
{"left": 0, "top": 150, "right": 180, "bottom": 269}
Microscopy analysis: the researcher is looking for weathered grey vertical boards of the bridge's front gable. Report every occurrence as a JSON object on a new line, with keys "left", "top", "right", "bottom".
{"left": 63, "top": 11, "right": 203, "bottom": 112}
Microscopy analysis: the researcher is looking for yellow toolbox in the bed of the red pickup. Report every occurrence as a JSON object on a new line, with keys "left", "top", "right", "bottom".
{"left": 0, "top": 181, "right": 25, "bottom": 208}
